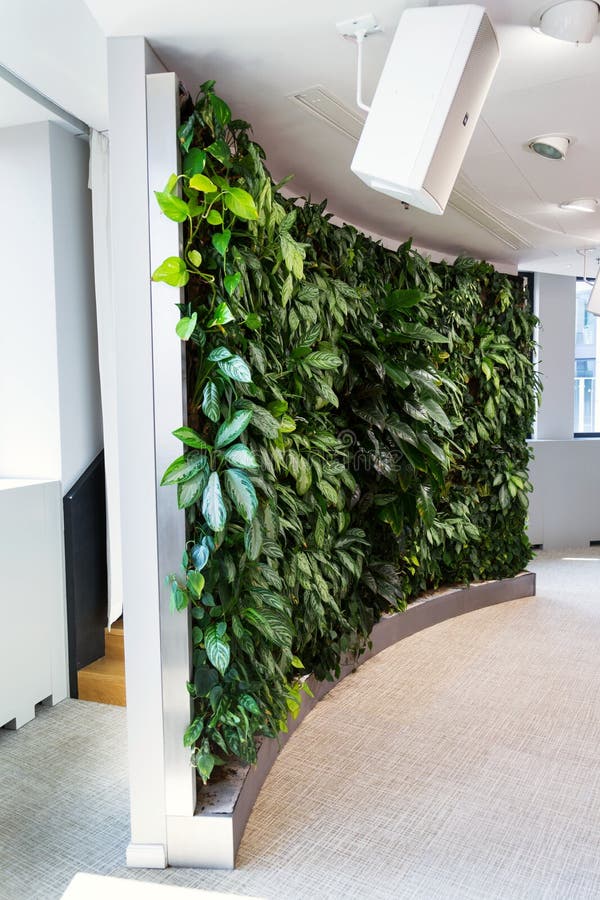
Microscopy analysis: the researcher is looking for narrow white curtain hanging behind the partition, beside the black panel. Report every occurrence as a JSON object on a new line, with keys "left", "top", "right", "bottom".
{"left": 89, "top": 129, "right": 123, "bottom": 626}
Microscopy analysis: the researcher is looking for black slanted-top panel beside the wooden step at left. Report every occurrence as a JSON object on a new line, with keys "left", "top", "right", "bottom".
{"left": 63, "top": 453, "right": 108, "bottom": 697}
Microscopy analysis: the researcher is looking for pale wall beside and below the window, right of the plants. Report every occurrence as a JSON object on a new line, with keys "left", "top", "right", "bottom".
{"left": 528, "top": 273, "right": 600, "bottom": 550}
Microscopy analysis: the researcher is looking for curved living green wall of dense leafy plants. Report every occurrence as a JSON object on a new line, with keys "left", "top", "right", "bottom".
{"left": 153, "top": 82, "right": 537, "bottom": 781}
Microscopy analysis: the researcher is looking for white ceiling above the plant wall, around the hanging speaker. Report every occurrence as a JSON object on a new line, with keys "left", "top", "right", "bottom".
{"left": 0, "top": 0, "right": 600, "bottom": 273}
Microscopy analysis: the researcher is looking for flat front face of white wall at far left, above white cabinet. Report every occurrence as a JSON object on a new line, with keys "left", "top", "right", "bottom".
{"left": 0, "top": 123, "right": 61, "bottom": 480}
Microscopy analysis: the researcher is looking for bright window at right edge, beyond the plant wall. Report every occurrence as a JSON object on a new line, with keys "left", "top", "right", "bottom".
{"left": 574, "top": 279, "right": 600, "bottom": 436}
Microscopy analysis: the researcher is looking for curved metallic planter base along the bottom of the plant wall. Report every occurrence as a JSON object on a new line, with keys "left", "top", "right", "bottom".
{"left": 167, "top": 572, "right": 535, "bottom": 869}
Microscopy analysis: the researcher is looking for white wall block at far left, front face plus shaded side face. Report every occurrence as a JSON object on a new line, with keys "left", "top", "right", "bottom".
{"left": 0, "top": 123, "right": 102, "bottom": 494}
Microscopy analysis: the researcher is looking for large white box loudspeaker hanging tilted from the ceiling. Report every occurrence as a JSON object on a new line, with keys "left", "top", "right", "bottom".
{"left": 352, "top": 4, "right": 500, "bottom": 215}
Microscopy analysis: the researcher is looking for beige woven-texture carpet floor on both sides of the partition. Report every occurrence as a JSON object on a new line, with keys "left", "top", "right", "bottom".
{"left": 0, "top": 548, "right": 600, "bottom": 900}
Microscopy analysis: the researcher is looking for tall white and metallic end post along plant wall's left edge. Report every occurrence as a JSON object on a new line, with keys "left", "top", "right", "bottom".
{"left": 105, "top": 38, "right": 195, "bottom": 867}
